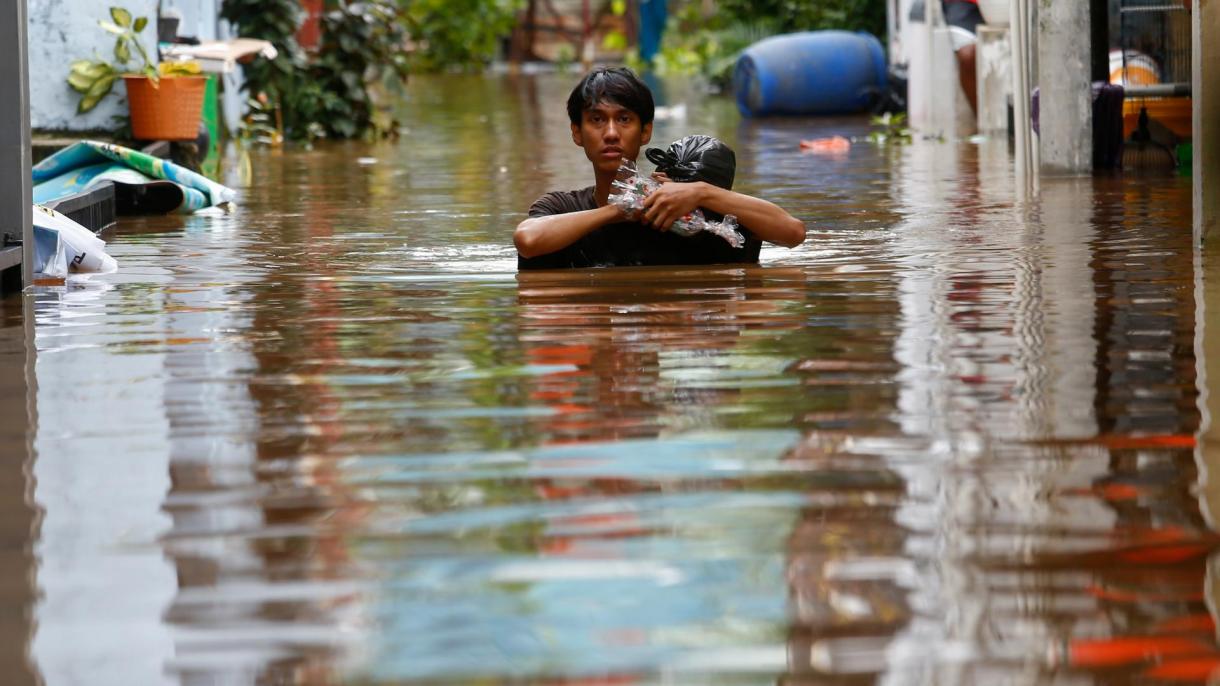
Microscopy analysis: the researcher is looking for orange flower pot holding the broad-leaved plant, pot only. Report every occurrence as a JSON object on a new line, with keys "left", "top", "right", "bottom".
{"left": 123, "top": 74, "right": 207, "bottom": 140}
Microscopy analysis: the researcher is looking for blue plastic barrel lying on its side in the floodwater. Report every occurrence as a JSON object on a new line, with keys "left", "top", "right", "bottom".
{"left": 733, "top": 31, "right": 886, "bottom": 116}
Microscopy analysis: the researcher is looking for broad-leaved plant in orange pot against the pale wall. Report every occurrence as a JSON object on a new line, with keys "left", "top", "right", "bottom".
{"left": 68, "top": 7, "right": 207, "bottom": 140}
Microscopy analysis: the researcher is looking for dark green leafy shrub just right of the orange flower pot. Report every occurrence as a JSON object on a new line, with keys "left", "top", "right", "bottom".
{"left": 221, "top": 0, "right": 407, "bottom": 142}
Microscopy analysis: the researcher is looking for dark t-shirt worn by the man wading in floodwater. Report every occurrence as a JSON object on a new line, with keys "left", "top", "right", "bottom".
{"left": 517, "top": 186, "right": 763, "bottom": 270}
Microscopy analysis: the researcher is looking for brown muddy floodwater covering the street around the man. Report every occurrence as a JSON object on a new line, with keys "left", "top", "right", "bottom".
{"left": 0, "top": 76, "right": 1220, "bottom": 685}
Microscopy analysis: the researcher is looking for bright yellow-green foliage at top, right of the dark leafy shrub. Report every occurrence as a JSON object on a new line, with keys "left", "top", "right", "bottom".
{"left": 399, "top": 0, "right": 525, "bottom": 71}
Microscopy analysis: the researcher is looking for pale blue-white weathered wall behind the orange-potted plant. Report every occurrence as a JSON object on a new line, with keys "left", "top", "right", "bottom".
{"left": 27, "top": 0, "right": 220, "bottom": 131}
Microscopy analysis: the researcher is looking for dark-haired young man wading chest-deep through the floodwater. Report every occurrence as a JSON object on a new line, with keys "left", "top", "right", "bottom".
{"left": 512, "top": 68, "right": 805, "bottom": 270}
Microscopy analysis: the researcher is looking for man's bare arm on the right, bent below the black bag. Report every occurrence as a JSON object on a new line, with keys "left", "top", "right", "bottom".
{"left": 643, "top": 181, "right": 805, "bottom": 248}
